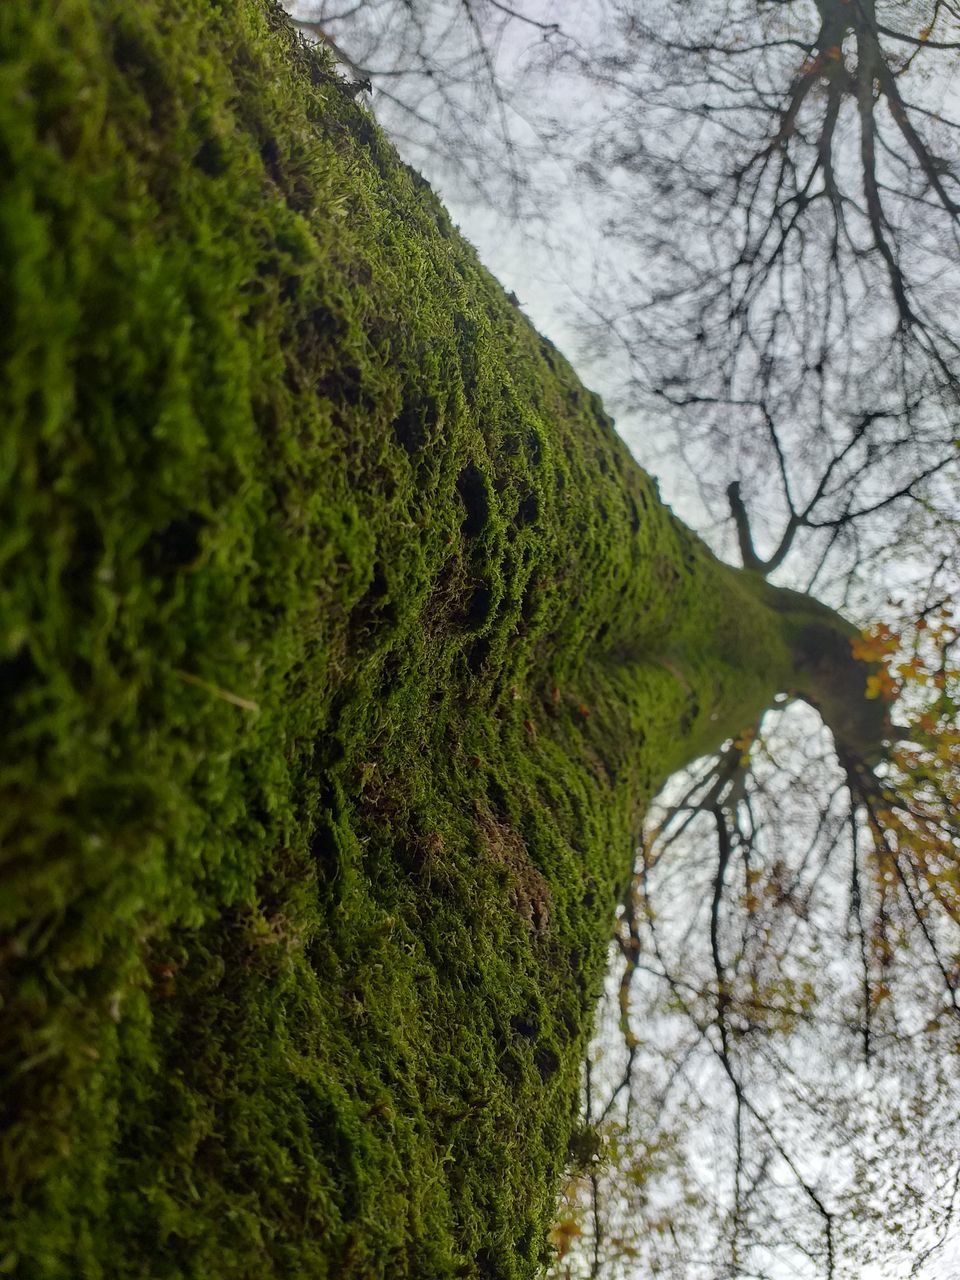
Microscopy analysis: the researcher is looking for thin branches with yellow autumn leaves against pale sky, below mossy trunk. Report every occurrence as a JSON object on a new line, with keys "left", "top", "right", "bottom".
{"left": 568, "top": 627, "right": 960, "bottom": 1277}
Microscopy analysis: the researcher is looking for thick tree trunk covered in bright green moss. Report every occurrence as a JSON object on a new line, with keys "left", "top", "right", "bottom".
{"left": 0, "top": 0, "right": 878, "bottom": 1280}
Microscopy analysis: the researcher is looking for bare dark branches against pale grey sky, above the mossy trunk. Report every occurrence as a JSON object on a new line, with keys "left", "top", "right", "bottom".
{"left": 293, "top": 0, "right": 960, "bottom": 593}
